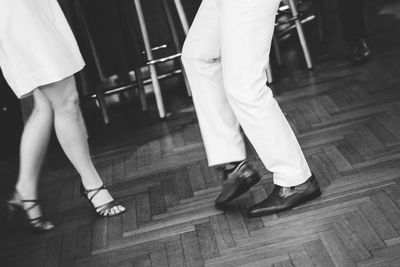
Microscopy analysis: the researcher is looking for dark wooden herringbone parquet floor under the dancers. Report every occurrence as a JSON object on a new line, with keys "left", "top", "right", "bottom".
{"left": 0, "top": 11, "right": 400, "bottom": 267}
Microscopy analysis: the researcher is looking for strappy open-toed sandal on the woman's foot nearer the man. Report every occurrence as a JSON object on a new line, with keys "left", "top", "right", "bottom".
{"left": 80, "top": 183, "right": 126, "bottom": 217}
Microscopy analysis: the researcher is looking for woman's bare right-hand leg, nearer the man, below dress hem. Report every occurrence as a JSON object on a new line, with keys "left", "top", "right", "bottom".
{"left": 40, "top": 76, "right": 124, "bottom": 213}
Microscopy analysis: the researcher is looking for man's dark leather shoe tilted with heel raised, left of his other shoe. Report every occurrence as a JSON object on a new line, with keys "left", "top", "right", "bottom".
{"left": 215, "top": 161, "right": 261, "bottom": 208}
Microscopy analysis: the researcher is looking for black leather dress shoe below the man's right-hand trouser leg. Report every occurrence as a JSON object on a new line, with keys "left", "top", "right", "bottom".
{"left": 248, "top": 174, "right": 321, "bottom": 217}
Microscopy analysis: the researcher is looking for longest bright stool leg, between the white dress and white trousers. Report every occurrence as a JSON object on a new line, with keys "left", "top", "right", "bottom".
{"left": 134, "top": 0, "right": 166, "bottom": 118}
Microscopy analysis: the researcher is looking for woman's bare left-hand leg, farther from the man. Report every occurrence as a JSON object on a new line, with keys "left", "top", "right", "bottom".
{"left": 16, "top": 89, "right": 53, "bottom": 221}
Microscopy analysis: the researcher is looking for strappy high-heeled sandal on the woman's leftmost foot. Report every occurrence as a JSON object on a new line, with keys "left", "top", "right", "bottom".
{"left": 7, "top": 199, "right": 54, "bottom": 232}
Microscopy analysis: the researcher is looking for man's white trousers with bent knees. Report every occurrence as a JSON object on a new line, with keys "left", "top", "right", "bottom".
{"left": 182, "top": 0, "right": 311, "bottom": 186}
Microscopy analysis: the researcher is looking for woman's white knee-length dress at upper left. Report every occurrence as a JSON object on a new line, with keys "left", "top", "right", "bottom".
{"left": 0, "top": 0, "right": 85, "bottom": 98}
